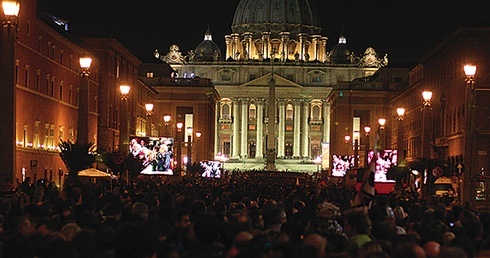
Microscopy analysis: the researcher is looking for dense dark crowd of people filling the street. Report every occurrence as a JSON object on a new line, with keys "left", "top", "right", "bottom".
{"left": 0, "top": 171, "right": 490, "bottom": 258}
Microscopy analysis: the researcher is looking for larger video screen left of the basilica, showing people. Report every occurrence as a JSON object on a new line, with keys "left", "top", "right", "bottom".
{"left": 129, "top": 137, "right": 174, "bottom": 175}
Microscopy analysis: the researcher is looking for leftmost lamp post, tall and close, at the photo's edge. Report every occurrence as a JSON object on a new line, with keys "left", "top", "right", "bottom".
{"left": 0, "top": 0, "right": 20, "bottom": 178}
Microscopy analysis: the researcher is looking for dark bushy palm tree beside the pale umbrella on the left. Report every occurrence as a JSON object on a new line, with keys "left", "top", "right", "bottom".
{"left": 58, "top": 140, "right": 97, "bottom": 187}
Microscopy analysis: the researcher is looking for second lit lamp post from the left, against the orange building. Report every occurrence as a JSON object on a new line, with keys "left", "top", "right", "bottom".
{"left": 77, "top": 56, "right": 92, "bottom": 144}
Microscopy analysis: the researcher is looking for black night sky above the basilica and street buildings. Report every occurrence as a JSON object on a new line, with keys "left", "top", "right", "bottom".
{"left": 38, "top": 0, "right": 490, "bottom": 66}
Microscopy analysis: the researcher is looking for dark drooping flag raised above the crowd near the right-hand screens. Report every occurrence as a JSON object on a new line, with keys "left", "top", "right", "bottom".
{"left": 352, "top": 130, "right": 379, "bottom": 207}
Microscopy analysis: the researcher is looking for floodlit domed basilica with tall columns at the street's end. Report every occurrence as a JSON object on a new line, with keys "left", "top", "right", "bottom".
{"left": 154, "top": 0, "right": 388, "bottom": 173}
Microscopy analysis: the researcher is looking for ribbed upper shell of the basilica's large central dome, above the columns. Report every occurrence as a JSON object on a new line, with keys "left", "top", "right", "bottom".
{"left": 231, "top": 0, "right": 321, "bottom": 35}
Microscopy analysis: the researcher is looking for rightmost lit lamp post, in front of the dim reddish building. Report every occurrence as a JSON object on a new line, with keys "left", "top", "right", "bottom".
{"left": 462, "top": 64, "right": 476, "bottom": 206}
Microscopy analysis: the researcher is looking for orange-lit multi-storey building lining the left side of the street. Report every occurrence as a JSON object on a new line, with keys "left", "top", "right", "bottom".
{"left": 0, "top": 1, "right": 151, "bottom": 185}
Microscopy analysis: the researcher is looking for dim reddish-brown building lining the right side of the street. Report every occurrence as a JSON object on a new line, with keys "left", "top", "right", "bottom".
{"left": 392, "top": 28, "right": 490, "bottom": 206}
